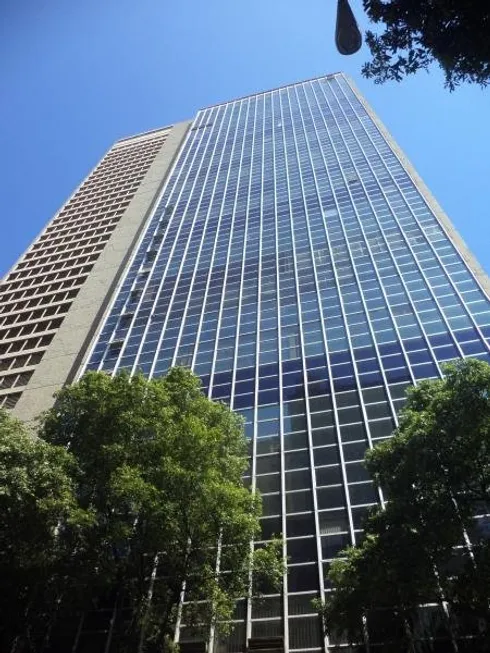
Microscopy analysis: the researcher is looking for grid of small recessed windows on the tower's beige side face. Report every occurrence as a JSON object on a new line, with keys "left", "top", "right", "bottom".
{"left": 0, "top": 131, "right": 168, "bottom": 408}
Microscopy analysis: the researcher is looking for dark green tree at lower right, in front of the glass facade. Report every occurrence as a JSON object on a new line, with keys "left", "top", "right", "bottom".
{"left": 323, "top": 360, "right": 490, "bottom": 651}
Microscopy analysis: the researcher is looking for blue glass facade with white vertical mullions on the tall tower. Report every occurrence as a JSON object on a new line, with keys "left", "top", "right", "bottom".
{"left": 85, "top": 74, "right": 490, "bottom": 653}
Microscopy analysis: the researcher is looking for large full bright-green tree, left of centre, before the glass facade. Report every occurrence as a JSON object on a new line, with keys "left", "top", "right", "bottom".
{"left": 41, "top": 368, "right": 283, "bottom": 651}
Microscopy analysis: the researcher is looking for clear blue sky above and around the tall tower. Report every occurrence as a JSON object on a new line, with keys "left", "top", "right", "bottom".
{"left": 0, "top": 0, "right": 490, "bottom": 275}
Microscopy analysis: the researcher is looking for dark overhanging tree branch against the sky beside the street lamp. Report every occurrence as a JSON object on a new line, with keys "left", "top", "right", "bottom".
{"left": 363, "top": 0, "right": 490, "bottom": 90}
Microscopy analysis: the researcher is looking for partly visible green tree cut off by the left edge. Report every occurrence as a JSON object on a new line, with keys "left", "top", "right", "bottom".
{"left": 0, "top": 410, "right": 90, "bottom": 652}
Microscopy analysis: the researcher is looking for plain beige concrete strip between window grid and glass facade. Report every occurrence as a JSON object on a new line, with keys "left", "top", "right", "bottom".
{"left": 12, "top": 121, "right": 191, "bottom": 422}
